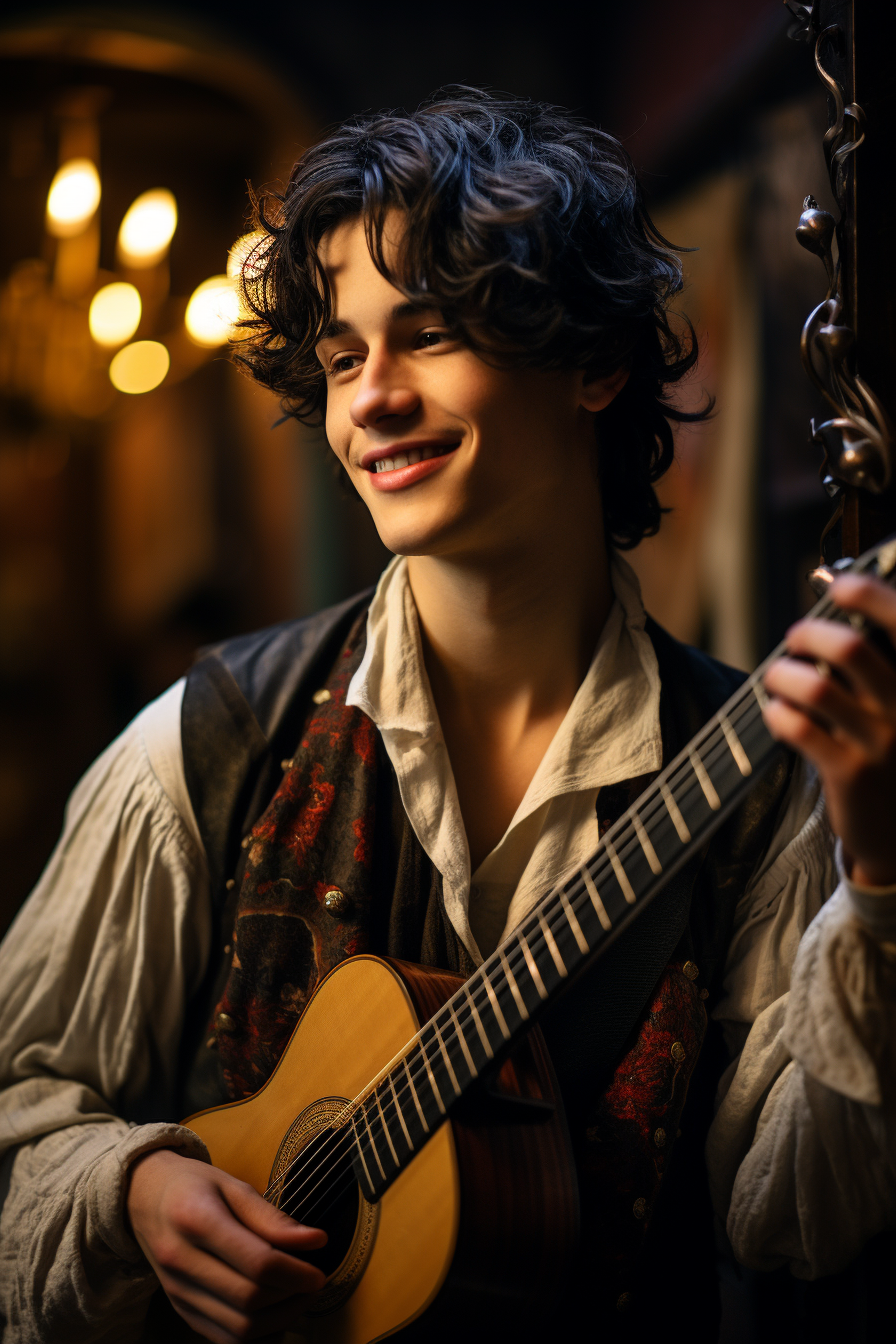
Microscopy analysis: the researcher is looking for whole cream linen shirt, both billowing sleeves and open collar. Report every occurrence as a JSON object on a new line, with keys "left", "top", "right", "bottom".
{"left": 0, "top": 560, "right": 896, "bottom": 1344}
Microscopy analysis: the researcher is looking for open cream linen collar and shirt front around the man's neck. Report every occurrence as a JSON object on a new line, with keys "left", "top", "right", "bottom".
{"left": 345, "top": 556, "right": 662, "bottom": 965}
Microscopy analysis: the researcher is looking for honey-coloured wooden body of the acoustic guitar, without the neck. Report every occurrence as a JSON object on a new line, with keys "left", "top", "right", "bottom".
{"left": 185, "top": 956, "right": 578, "bottom": 1344}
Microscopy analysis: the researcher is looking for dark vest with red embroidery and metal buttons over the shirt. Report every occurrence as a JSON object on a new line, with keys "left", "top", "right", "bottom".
{"left": 181, "top": 597, "right": 793, "bottom": 1335}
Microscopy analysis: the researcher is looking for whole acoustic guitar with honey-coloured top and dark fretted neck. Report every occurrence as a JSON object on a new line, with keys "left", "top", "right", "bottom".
{"left": 185, "top": 539, "right": 896, "bottom": 1344}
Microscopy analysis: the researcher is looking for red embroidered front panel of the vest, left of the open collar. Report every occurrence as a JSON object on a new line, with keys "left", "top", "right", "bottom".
{"left": 215, "top": 626, "right": 376, "bottom": 1099}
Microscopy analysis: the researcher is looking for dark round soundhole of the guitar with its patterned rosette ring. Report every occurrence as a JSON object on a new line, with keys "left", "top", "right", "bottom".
{"left": 267, "top": 1097, "right": 379, "bottom": 1314}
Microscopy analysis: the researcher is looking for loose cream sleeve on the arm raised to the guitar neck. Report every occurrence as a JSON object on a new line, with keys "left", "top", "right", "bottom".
{"left": 707, "top": 767, "right": 896, "bottom": 1278}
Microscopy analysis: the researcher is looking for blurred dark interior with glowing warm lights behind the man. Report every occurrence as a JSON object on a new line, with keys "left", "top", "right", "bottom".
{"left": 0, "top": 0, "right": 830, "bottom": 930}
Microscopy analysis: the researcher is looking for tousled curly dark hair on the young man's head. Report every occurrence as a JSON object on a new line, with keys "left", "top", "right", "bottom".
{"left": 236, "top": 86, "right": 711, "bottom": 548}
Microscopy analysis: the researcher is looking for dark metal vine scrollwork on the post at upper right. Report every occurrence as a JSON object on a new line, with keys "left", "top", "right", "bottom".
{"left": 785, "top": 0, "right": 893, "bottom": 499}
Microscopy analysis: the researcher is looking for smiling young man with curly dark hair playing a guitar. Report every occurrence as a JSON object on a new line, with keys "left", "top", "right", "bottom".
{"left": 0, "top": 91, "right": 896, "bottom": 1344}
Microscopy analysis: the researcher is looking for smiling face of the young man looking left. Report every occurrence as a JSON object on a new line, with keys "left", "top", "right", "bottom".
{"left": 317, "top": 216, "right": 619, "bottom": 560}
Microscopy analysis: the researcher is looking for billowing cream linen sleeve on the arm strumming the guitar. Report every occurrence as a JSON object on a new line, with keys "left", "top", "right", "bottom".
{"left": 0, "top": 683, "right": 211, "bottom": 1344}
